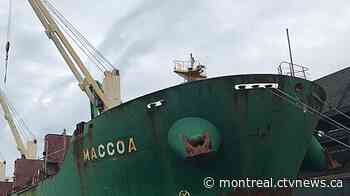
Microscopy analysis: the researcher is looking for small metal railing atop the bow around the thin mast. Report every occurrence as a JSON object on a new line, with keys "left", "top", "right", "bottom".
{"left": 277, "top": 61, "right": 309, "bottom": 79}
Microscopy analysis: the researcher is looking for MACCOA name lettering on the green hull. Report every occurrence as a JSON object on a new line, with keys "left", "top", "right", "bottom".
{"left": 82, "top": 137, "right": 137, "bottom": 161}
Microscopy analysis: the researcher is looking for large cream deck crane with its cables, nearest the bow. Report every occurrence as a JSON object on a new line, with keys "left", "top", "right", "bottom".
{"left": 28, "top": 0, "right": 121, "bottom": 118}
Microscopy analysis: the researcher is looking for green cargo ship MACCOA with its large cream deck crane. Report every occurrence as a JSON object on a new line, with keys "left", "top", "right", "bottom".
{"left": 0, "top": 0, "right": 326, "bottom": 196}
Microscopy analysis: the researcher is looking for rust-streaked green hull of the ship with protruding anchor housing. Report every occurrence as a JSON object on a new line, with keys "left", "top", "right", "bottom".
{"left": 12, "top": 75, "right": 325, "bottom": 196}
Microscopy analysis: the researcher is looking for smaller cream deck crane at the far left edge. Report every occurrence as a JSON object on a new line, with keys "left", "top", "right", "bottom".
{"left": 0, "top": 89, "right": 37, "bottom": 159}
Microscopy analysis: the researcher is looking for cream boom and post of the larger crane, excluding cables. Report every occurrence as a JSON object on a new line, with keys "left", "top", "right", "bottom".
{"left": 28, "top": 0, "right": 120, "bottom": 115}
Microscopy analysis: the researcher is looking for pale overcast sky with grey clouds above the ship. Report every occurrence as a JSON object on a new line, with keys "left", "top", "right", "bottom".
{"left": 0, "top": 0, "right": 350, "bottom": 175}
